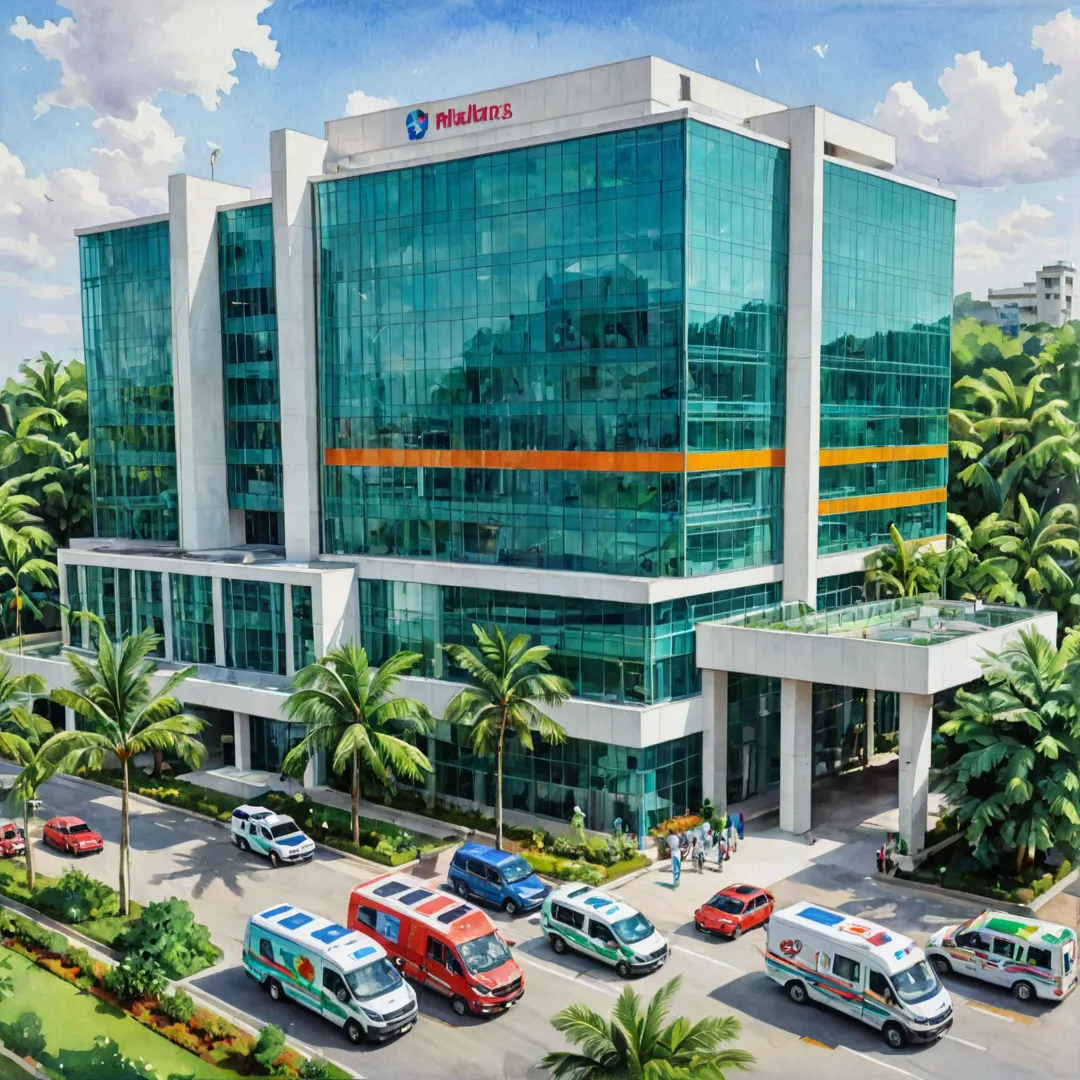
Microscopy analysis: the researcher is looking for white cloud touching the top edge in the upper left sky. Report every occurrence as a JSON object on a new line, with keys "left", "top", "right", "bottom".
{"left": 11, "top": 0, "right": 280, "bottom": 120}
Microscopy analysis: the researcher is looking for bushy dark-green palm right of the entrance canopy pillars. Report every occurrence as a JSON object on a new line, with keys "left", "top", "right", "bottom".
{"left": 940, "top": 630, "right": 1080, "bottom": 873}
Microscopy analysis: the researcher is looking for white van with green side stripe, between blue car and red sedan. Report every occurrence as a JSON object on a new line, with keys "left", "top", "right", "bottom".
{"left": 540, "top": 883, "right": 670, "bottom": 978}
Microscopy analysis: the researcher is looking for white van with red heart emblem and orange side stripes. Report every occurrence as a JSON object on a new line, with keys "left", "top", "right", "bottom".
{"left": 765, "top": 901, "right": 953, "bottom": 1050}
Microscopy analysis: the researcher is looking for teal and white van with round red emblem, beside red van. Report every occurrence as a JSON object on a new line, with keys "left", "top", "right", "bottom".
{"left": 244, "top": 904, "right": 417, "bottom": 1043}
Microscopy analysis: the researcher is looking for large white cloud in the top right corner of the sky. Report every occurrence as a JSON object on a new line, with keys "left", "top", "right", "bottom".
{"left": 874, "top": 11, "right": 1080, "bottom": 187}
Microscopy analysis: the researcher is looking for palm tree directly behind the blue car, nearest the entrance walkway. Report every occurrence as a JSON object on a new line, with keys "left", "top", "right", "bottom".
{"left": 443, "top": 623, "right": 573, "bottom": 849}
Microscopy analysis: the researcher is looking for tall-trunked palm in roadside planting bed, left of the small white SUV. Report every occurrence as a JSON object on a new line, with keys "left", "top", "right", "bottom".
{"left": 52, "top": 625, "right": 206, "bottom": 915}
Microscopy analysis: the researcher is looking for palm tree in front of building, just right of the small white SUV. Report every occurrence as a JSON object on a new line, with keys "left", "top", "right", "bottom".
{"left": 282, "top": 642, "right": 435, "bottom": 843}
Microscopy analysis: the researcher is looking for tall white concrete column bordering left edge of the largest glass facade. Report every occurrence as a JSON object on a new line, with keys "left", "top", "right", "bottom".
{"left": 270, "top": 129, "right": 326, "bottom": 561}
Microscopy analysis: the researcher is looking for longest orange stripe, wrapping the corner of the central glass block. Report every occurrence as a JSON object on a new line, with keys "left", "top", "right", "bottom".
{"left": 324, "top": 447, "right": 784, "bottom": 473}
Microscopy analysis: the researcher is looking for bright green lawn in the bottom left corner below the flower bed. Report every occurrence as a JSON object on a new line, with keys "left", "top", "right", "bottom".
{"left": 0, "top": 946, "right": 237, "bottom": 1080}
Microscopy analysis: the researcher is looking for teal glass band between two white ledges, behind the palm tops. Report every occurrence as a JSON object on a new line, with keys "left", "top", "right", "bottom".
{"left": 359, "top": 580, "right": 780, "bottom": 705}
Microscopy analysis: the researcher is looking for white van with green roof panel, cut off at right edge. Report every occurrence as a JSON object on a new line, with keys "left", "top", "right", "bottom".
{"left": 927, "top": 912, "right": 1077, "bottom": 1001}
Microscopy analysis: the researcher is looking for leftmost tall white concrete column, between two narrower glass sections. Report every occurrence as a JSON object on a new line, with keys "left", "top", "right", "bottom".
{"left": 168, "top": 175, "right": 252, "bottom": 549}
